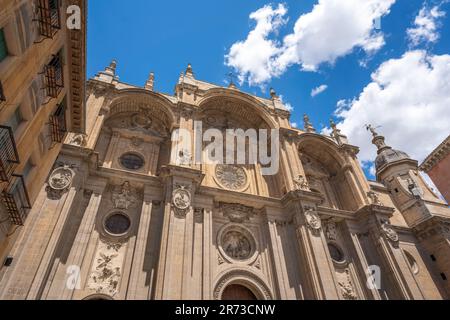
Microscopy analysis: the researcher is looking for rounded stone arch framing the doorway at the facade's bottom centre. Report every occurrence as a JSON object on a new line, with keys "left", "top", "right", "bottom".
{"left": 213, "top": 269, "right": 274, "bottom": 300}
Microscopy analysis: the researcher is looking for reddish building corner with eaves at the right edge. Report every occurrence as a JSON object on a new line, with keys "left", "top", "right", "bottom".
{"left": 420, "top": 136, "right": 450, "bottom": 203}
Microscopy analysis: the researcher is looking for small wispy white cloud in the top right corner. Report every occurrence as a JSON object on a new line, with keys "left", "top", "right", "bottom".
{"left": 407, "top": 6, "right": 445, "bottom": 46}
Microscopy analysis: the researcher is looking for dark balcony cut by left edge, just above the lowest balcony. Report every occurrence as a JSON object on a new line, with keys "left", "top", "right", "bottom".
{"left": 0, "top": 126, "right": 19, "bottom": 182}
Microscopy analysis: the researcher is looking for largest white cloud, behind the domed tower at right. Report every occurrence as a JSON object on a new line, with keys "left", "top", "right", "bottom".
{"left": 336, "top": 50, "right": 450, "bottom": 163}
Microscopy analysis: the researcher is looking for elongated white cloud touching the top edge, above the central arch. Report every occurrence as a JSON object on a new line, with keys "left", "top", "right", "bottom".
{"left": 226, "top": 0, "right": 396, "bottom": 85}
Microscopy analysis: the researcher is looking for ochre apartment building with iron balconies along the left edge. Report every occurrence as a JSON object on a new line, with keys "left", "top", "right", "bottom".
{"left": 0, "top": 0, "right": 86, "bottom": 265}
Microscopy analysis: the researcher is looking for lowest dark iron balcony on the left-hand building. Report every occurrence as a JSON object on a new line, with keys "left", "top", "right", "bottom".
{"left": 2, "top": 175, "right": 31, "bottom": 226}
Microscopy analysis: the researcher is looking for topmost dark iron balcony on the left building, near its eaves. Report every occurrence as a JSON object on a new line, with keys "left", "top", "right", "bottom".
{"left": 35, "top": 0, "right": 61, "bottom": 39}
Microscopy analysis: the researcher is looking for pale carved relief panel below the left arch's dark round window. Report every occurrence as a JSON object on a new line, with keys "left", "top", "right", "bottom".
{"left": 88, "top": 241, "right": 125, "bottom": 297}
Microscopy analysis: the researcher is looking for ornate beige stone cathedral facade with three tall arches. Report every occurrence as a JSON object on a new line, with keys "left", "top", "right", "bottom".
{"left": 0, "top": 62, "right": 450, "bottom": 300}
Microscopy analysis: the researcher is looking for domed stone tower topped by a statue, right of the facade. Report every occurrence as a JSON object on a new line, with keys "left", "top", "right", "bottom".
{"left": 367, "top": 125, "right": 450, "bottom": 295}
